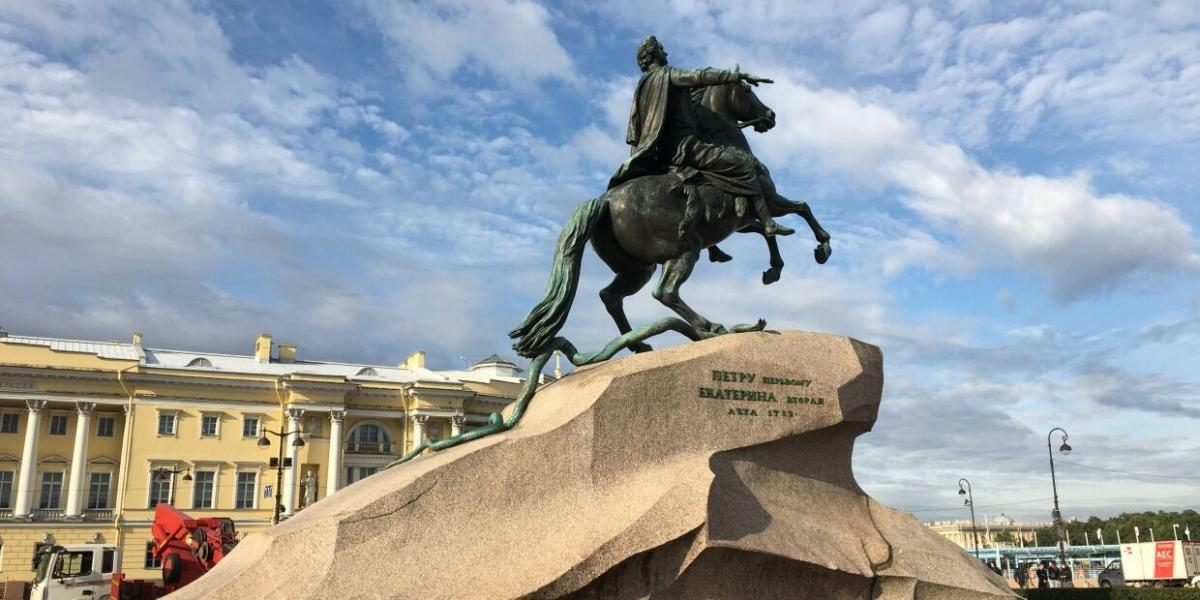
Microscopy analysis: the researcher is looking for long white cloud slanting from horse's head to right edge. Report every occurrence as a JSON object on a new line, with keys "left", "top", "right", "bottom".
{"left": 761, "top": 80, "right": 1200, "bottom": 300}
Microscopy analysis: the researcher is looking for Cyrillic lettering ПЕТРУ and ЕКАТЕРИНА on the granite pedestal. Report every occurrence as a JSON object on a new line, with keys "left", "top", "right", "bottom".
{"left": 696, "top": 371, "right": 824, "bottom": 418}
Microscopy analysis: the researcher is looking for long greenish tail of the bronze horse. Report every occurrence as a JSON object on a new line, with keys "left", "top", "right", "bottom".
{"left": 509, "top": 197, "right": 607, "bottom": 358}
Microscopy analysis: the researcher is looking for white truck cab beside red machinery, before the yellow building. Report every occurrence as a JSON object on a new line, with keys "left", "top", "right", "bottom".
{"left": 29, "top": 544, "right": 120, "bottom": 600}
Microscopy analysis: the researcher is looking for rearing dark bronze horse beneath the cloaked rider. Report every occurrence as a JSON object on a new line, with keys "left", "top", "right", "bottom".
{"left": 509, "top": 77, "right": 832, "bottom": 358}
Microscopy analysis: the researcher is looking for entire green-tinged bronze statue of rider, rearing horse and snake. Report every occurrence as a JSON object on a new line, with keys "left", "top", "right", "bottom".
{"left": 392, "top": 36, "right": 832, "bottom": 464}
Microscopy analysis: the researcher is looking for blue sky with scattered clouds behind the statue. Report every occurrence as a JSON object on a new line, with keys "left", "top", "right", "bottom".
{"left": 0, "top": 0, "right": 1200, "bottom": 520}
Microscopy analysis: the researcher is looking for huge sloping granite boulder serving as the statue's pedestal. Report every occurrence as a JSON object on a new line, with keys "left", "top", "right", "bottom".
{"left": 170, "top": 331, "right": 1014, "bottom": 600}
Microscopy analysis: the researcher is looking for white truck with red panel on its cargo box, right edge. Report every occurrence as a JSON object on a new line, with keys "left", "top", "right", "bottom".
{"left": 1098, "top": 540, "right": 1200, "bottom": 588}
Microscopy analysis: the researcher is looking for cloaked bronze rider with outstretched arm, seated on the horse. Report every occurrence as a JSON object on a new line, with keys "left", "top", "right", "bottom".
{"left": 608, "top": 36, "right": 794, "bottom": 235}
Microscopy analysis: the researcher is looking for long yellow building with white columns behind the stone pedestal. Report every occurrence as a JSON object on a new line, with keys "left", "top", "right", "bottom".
{"left": 0, "top": 331, "right": 523, "bottom": 581}
